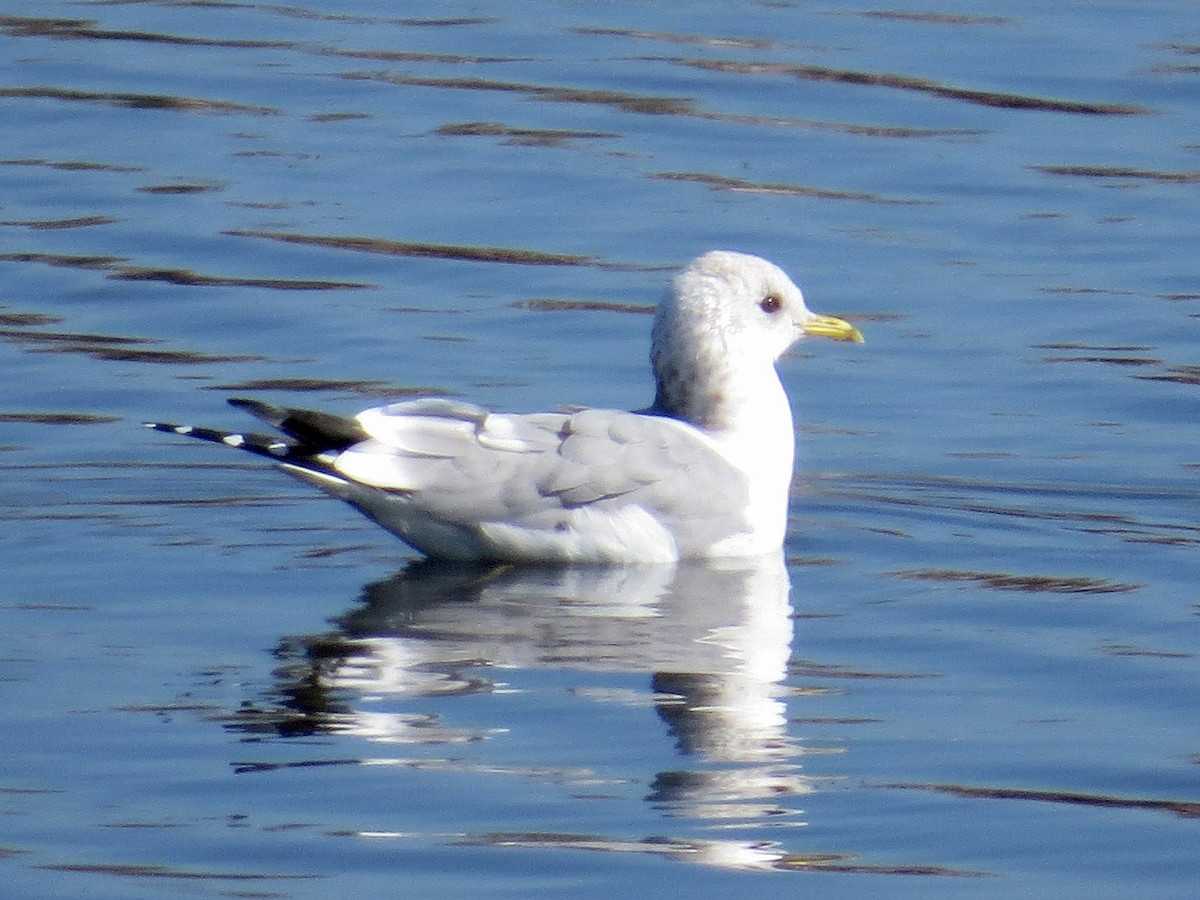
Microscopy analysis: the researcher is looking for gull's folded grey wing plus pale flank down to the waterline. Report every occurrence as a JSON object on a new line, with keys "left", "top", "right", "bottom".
{"left": 322, "top": 400, "right": 748, "bottom": 559}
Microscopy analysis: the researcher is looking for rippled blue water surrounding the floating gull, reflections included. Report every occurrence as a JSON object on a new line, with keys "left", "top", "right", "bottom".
{"left": 0, "top": 0, "right": 1200, "bottom": 898}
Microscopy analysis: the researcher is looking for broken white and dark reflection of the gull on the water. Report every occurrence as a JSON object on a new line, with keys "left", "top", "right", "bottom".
{"left": 229, "top": 554, "right": 811, "bottom": 865}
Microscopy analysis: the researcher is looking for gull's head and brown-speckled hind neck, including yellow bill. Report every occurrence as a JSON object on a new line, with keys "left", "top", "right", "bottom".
{"left": 650, "top": 250, "right": 863, "bottom": 424}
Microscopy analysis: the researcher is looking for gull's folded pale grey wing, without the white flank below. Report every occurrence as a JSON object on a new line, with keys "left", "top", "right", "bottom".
{"left": 335, "top": 400, "right": 749, "bottom": 553}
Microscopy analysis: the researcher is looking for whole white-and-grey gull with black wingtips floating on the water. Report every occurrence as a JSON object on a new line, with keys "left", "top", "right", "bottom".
{"left": 145, "top": 251, "right": 863, "bottom": 563}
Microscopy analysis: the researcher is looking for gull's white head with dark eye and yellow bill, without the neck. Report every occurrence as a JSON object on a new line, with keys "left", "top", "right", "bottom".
{"left": 654, "top": 250, "right": 863, "bottom": 362}
